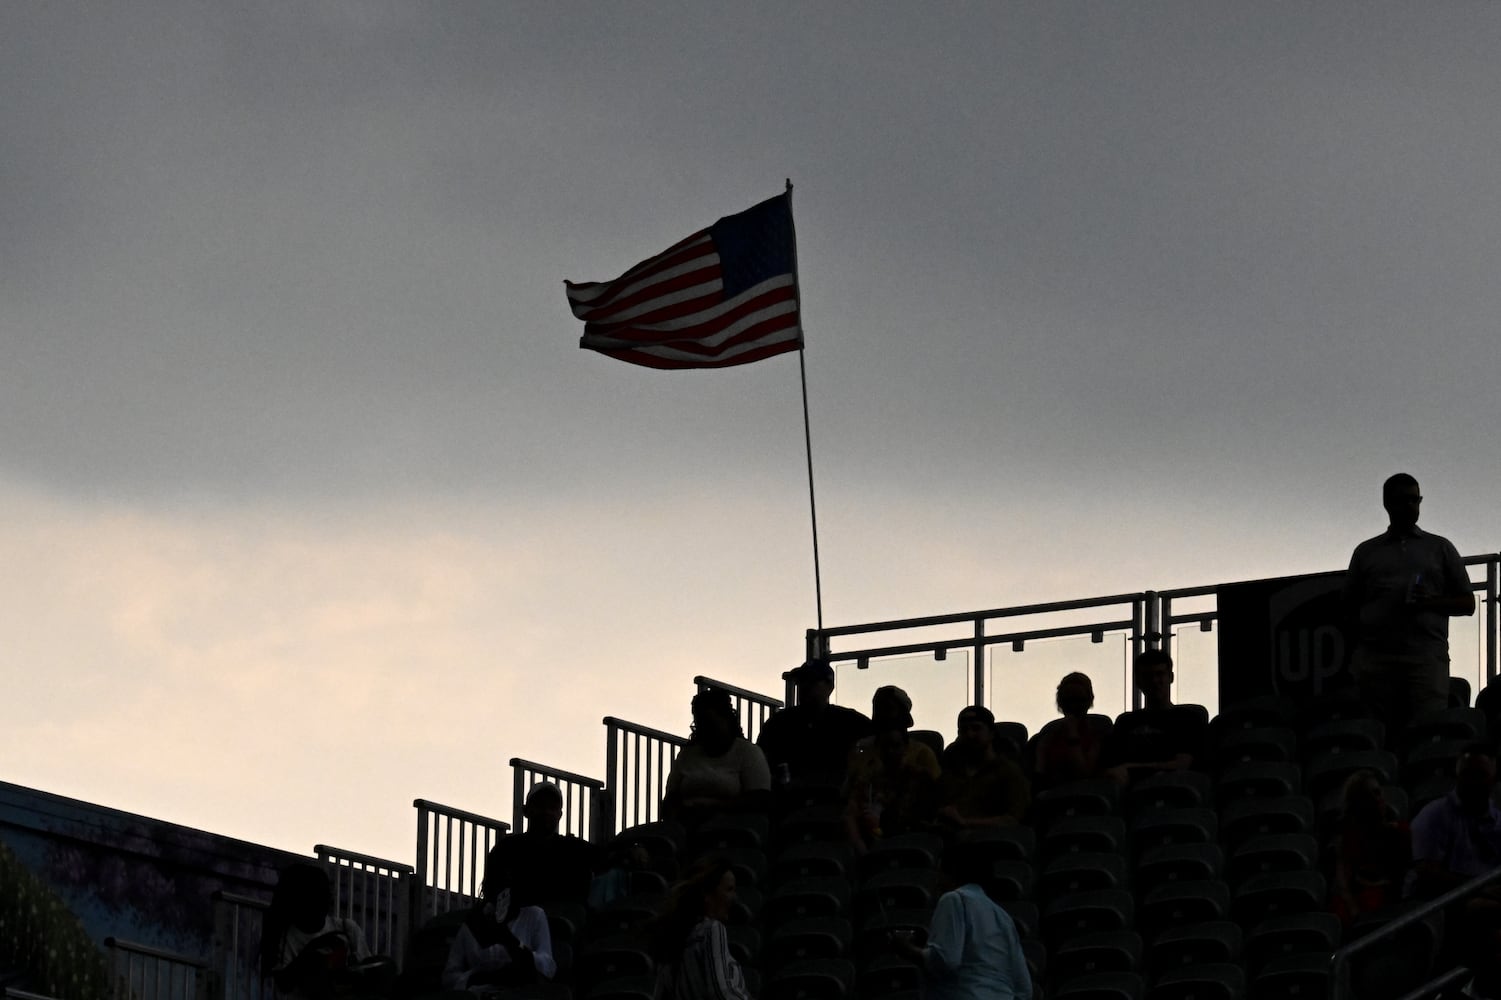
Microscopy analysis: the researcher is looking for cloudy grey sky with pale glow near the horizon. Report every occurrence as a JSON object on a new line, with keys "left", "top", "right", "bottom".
{"left": 0, "top": 2, "right": 1501, "bottom": 859}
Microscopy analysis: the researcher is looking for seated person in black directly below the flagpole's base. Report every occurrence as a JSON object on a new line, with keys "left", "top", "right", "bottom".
{"left": 757, "top": 659, "right": 871, "bottom": 784}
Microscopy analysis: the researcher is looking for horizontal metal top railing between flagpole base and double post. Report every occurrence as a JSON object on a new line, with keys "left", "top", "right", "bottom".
{"left": 810, "top": 592, "right": 1160, "bottom": 704}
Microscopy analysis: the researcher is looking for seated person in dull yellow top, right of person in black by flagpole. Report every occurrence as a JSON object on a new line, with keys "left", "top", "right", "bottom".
{"left": 845, "top": 686, "right": 941, "bottom": 854}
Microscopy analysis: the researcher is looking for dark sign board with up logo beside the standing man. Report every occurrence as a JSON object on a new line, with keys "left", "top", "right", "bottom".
{"left": 1217, "top": 572, "right": 1351, "bottom": 704}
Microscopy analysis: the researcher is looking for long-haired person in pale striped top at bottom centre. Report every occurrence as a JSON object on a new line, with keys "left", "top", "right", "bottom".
{"left": 650, "top": 859, "right": 752, "bottom": 1000}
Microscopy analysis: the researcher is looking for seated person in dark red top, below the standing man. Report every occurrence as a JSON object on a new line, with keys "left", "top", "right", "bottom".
{"left": 1328, "top": 770, "right": 1412, "bottom": 926}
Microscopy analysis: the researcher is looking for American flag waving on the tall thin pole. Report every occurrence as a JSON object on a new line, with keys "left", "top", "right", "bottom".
{"left": 564, "top": 191, "right": 803, "bottom": 368}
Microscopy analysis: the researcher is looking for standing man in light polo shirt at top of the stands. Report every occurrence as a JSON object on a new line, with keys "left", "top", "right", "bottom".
{"left": 1345, "top": 473, "right": 1475, "bottom": 740}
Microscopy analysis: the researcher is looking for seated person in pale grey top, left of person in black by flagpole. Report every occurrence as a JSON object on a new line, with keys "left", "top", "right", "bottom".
{"left": 662, "top": 688, "right": 772, "bottom": 827}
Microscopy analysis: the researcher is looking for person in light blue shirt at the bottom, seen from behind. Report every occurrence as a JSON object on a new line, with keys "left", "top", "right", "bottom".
{"left": 889, "top": 844, "right": 1033, "bottom": 1000}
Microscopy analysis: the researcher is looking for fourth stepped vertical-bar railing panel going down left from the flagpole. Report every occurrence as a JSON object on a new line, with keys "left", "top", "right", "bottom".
{"left": 407, "top": 799, "right": 510, "bottom": 928}
